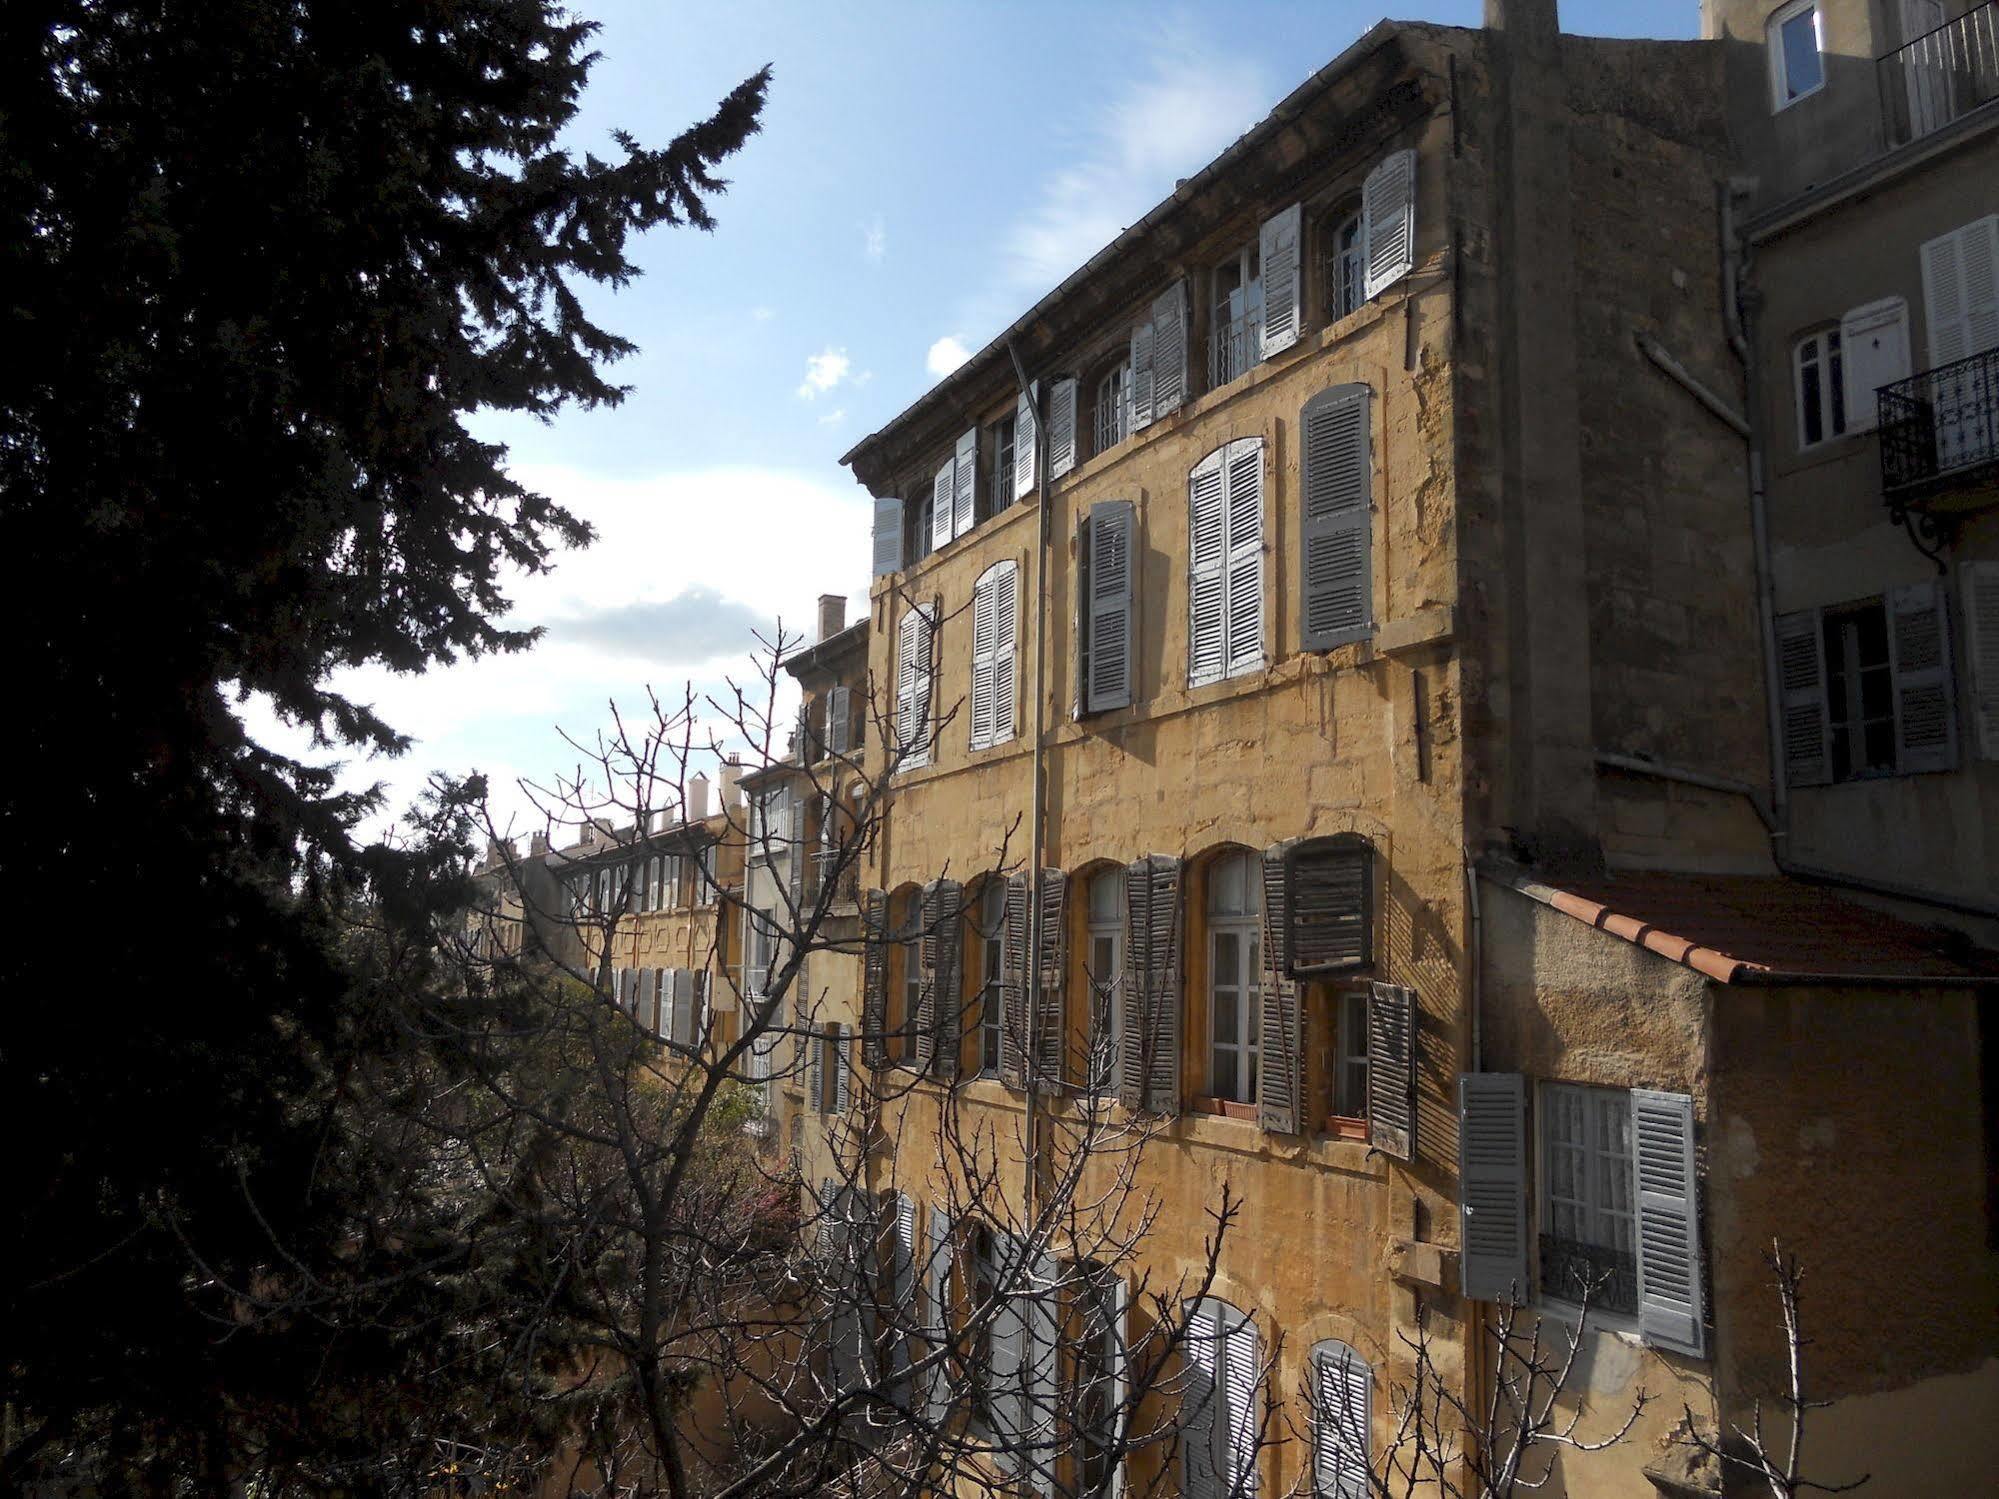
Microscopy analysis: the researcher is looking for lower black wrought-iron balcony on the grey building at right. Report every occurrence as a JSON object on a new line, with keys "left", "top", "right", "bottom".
{"left": 1877, "top": 349, "right": 1999, "bottom": 516}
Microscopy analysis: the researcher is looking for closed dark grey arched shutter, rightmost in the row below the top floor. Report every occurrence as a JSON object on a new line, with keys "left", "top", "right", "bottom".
{"left": 1299, "top": 386, "right": 1373, "bottom": 652}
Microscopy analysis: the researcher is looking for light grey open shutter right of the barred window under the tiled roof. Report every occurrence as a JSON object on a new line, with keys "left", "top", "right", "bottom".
{"left": 1631, "top": 1087, "right": 1705, "bottom": 1357}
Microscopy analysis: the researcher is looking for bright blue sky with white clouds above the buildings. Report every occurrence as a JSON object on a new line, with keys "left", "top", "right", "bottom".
{"left": 246, "top": 0, "right": 1699, "bottom": 847}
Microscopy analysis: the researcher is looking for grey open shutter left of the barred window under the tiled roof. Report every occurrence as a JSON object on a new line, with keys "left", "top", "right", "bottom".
{"left": 1457, "top": 1071, "right": 1527, "bottom": 1301}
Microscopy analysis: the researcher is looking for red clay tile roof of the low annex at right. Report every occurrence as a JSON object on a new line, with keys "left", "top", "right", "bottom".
{"left": 1487, "top": 865, "right": 1999, "bottom": 983}
